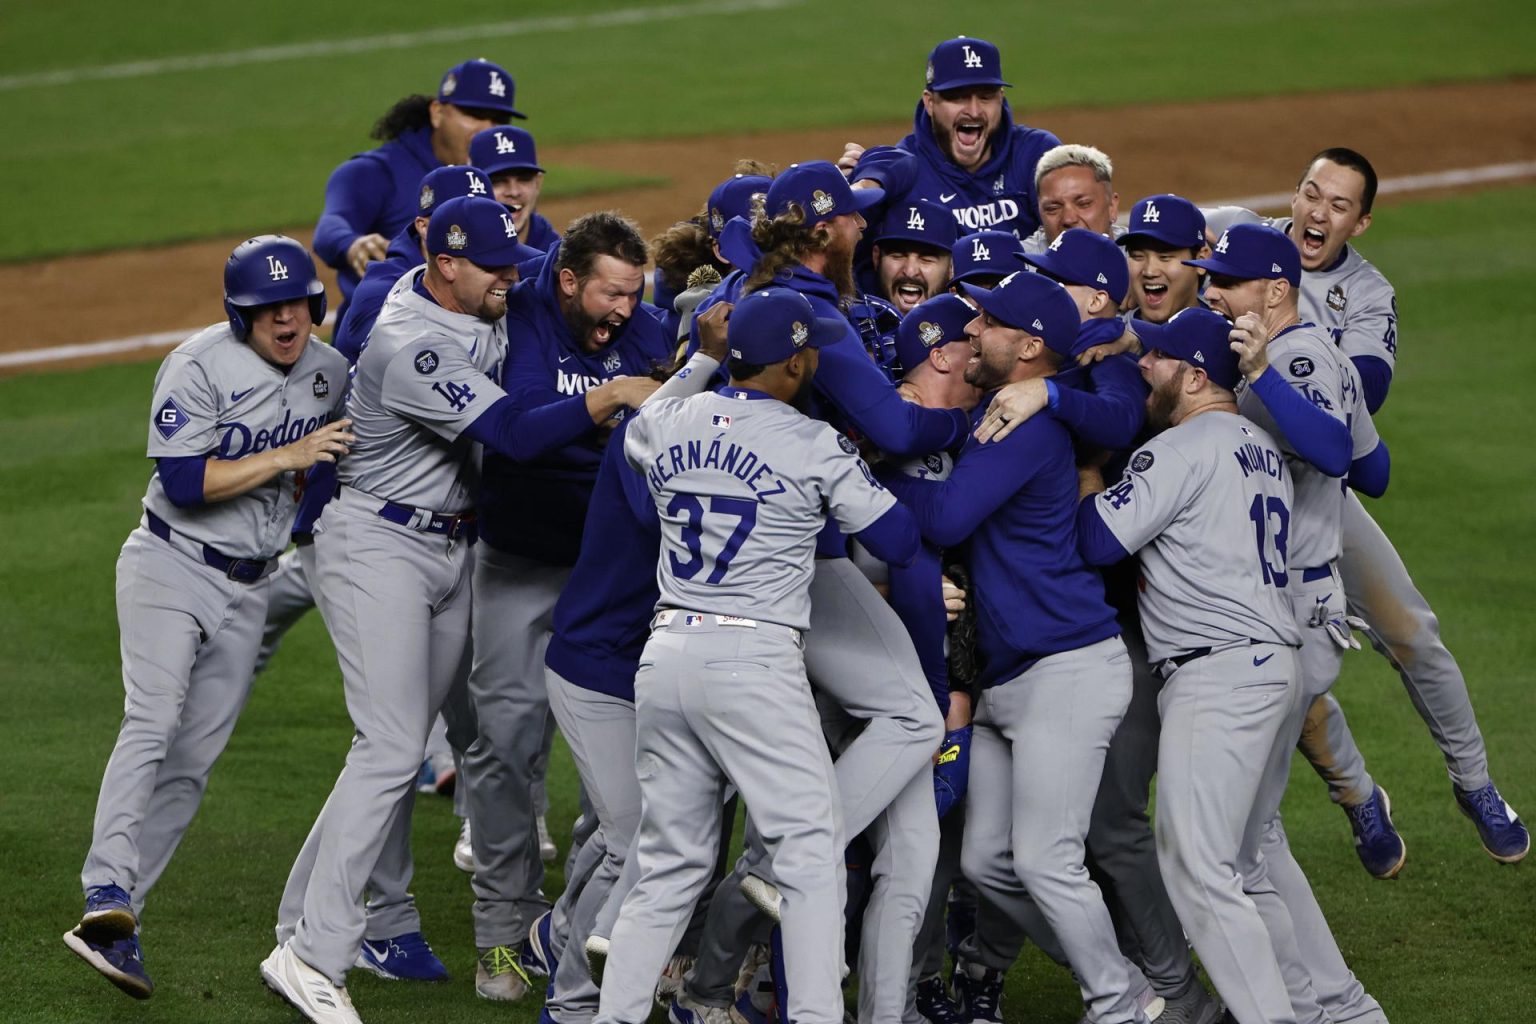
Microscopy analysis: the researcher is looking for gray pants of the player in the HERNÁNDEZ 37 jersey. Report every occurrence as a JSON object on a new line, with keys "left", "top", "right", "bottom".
{"left": 598, "top": 613, "right": 845, "bottom": 1024}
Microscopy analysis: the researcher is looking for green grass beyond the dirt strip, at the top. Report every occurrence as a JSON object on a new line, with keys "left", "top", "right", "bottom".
{"left": 0, "top": 0, "right": 1536, "bottom": 261}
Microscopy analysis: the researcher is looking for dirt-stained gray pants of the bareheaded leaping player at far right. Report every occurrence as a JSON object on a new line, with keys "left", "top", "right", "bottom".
{"left": 1303, "top": 491, "right": 1488, "bottom": 806}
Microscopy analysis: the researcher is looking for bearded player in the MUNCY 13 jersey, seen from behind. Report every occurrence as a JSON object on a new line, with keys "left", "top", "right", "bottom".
{"left": 1075, "top": 310, "right": 1301, "bottom": 1024}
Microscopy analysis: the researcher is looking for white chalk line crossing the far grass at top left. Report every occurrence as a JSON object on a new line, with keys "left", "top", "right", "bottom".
{"left": 0, "top": 0, "right": 805, "bottom": 92}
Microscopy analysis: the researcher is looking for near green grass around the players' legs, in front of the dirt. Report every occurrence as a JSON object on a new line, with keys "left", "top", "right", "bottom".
{"left": 0, "top": 189, "right": 1536, "bottom": 1024}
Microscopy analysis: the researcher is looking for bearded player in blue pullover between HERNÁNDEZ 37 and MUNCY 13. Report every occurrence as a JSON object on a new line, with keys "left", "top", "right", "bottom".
{"left": 889, "top": 273, "right": 1164, "bottom": 1024}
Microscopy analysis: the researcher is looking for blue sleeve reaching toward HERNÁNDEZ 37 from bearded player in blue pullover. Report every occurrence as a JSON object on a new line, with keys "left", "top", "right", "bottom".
{"left": 880, "top": 421, "right": 1060, "bottom": 548}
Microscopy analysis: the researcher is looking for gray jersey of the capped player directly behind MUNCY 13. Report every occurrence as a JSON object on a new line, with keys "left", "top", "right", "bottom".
{"left": 1236, "top": 324, "right": 1381, "bottom": 568}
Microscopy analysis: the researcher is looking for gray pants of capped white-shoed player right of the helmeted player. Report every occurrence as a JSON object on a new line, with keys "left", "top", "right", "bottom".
{"left": 289, "top": 488, "right": 472, "bottom": 984}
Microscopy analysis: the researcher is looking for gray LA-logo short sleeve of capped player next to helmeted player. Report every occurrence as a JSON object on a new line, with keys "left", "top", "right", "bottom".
{"left": 382, "top": 335, "right": 505, "bottom": 441}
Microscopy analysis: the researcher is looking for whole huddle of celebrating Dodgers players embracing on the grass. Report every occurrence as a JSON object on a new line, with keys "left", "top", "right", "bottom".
{"left": 65, "top": 37, "right": 1530, "bottom": 1024}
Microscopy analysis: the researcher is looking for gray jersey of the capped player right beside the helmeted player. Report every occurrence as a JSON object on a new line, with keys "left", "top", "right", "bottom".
{"left": 338, "top": 269, "right": 507, "bottom": 513}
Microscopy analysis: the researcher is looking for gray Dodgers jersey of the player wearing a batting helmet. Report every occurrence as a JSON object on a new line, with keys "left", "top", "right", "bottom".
{"left": 144, "top": 324, "right": 347, "bottom": 559}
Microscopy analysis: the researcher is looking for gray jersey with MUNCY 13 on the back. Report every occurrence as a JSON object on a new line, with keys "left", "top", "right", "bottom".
{"left": 1097, "top": 413, "right": 1301, "bottom": 663}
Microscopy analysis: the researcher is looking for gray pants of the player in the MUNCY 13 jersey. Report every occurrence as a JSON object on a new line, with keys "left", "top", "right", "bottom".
{"left": 1155, "top": 643, "right": 1301, "bottom": 1024}
